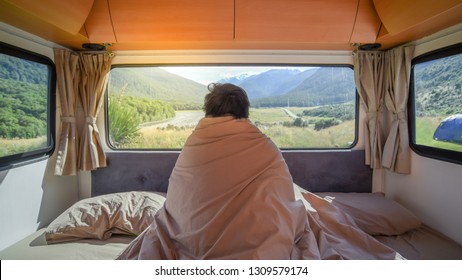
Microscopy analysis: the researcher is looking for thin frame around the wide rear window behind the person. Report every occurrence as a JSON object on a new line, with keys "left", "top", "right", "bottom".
{"left": 104, "top": 62, "right": 360, "bottom": 152}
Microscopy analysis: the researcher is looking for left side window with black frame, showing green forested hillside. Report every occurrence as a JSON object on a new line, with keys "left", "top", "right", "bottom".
{"left": 0, "top": 43, "right": 55, "bottom": 168}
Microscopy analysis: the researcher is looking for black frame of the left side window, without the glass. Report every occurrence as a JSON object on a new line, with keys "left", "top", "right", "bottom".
{"left": 0, "top": 42, "right": 56, "bottom": 170}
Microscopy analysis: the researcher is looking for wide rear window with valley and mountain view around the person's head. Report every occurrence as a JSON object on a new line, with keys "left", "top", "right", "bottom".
{"left": 107, "top": 65, "right": 357, "bottom": 149}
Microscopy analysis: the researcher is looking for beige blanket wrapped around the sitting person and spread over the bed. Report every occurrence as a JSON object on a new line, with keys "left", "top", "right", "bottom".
{"left": 119, "top": 117, "right": 402, "bottom": 259}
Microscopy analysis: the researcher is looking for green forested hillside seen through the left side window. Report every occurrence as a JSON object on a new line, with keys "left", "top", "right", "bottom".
{"left": 0, "top": 54, "right": 48, "bottom": 138}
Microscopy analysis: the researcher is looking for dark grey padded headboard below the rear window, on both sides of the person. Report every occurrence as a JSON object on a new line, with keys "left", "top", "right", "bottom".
{"left": 91, "top": 150, "right": 372, "bottom": 196}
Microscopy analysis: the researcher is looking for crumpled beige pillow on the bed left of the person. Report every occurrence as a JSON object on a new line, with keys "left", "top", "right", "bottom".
{"left": 45, "top": 191, "right": 165, "bottom": 244}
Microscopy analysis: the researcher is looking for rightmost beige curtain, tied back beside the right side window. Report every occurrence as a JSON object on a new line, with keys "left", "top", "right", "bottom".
{"left": 382, "top": 46, "right": 414, "bottom": 174}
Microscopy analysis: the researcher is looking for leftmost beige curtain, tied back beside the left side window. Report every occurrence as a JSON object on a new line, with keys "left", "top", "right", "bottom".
{"left": 54, "top": 49, "right": 79, "bottom": 175}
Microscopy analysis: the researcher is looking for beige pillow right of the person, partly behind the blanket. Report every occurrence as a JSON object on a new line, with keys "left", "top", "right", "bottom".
{"left": 317, "top": 193, "right": 421, "bottom": 236}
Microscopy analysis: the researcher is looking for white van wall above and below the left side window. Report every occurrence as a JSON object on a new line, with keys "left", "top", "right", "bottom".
{"left": 0, "top": 23, "right": 78, "bottom": 250}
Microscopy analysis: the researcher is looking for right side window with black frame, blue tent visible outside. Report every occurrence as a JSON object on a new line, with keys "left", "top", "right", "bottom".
{"left": 410, "top": 45, "right": 462, "bottom": 163}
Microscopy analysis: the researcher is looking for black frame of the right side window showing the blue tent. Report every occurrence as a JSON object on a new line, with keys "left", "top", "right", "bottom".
{"left": 408, "top": 43, "right": 462, "bottom": 164}
